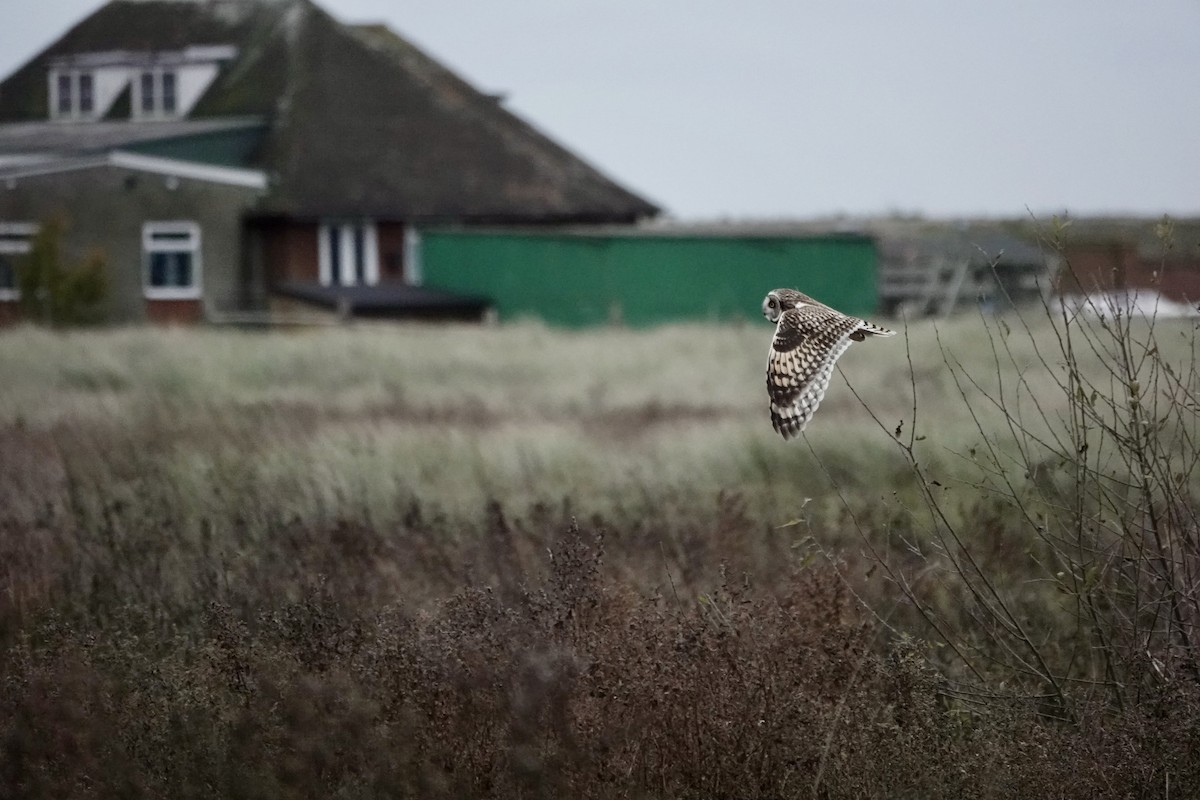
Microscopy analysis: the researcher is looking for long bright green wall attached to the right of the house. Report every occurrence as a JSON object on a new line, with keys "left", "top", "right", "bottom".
{"left": 420, "top": 230, "right": 876, "bottom": 325}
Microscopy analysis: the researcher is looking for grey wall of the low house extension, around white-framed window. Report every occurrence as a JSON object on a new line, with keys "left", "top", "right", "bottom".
{"left": 0, "top": 166, "right": 262, "bottom": 321}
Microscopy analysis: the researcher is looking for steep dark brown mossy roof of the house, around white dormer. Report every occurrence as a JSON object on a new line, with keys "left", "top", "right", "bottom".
{"left": 0, "top": 0, "right": 658, "bottom": 222}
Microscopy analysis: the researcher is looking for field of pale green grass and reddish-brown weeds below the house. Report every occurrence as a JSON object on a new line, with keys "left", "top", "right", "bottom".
{"left": 0, "top": 313, "right": 1200, "bottom": 798}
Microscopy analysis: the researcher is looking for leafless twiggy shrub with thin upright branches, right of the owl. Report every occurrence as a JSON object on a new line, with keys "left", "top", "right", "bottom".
{"left": 844, "top": 220, "right": 1200, "bottom": 722}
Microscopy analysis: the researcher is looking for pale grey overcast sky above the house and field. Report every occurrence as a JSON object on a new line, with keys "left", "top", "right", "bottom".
{"left": 0, "top": 0, "right": 1200, "bottom": 219}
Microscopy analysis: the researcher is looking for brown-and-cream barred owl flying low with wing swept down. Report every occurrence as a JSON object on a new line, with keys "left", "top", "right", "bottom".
{"left": 762, "top": 289, "right": 895, "bottom": 439}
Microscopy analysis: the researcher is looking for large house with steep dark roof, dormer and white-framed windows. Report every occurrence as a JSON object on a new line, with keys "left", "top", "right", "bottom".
{"left": 0, "top": 0, "right": 658, "bottom": 321}
